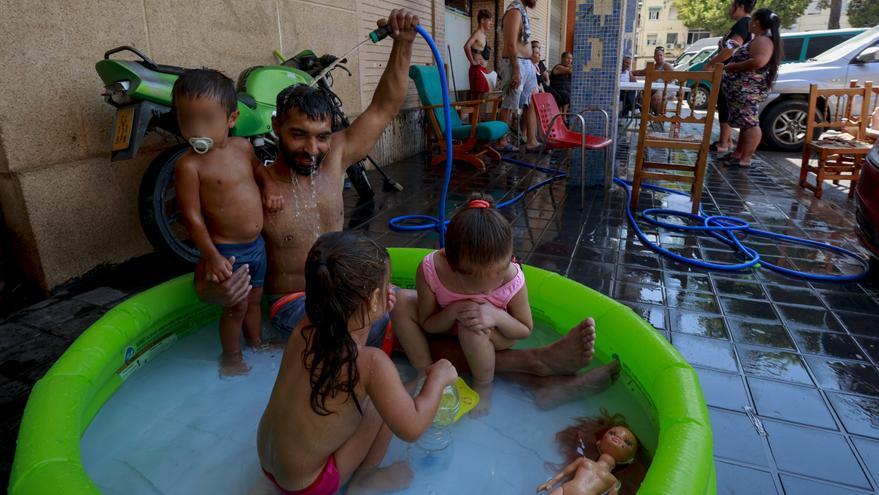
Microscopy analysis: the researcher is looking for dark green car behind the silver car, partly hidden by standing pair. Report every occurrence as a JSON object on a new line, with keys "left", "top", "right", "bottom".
{"left": 675, "top": 28, "right": 865, "bottom": 110}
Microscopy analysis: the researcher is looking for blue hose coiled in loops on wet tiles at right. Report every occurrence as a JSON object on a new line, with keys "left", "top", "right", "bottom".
{"left": 613, "top": 178, "right": 869, "bottom": 282}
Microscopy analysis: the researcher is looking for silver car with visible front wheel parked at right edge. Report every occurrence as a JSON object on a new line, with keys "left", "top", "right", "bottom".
{"left": 760, "top": 26, "right": 879, "bottom": 151}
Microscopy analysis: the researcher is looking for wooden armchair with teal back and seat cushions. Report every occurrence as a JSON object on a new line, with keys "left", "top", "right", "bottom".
{"left": 409, "top": 65, "right": 509, "bottom": 170}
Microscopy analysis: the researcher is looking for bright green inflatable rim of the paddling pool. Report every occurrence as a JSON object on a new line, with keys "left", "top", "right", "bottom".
{"left": 9, "top": 248, "right": 716, "bottom": 495}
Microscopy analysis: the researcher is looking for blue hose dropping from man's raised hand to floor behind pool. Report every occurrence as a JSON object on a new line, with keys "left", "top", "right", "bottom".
{"left": 388, "top": 26, "right": 567, "bottom": 248}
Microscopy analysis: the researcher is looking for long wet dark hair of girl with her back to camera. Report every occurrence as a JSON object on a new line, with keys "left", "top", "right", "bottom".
{"left": 302, "top": 231, "right": 389, "bottom": 416}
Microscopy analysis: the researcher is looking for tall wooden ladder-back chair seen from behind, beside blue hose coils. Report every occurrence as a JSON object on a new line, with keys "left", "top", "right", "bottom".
{"left": 632, "top": 62, "right": 723, "bottom": 214}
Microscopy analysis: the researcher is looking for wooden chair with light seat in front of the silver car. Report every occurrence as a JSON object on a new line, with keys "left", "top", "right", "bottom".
{"left": 800, "top": 81, "right": 873, "bottom": 199}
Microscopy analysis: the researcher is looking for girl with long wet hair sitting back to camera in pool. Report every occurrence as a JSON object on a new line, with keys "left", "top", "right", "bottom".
{"left": 257, "top": 231, "right": 458, "bottom": 495}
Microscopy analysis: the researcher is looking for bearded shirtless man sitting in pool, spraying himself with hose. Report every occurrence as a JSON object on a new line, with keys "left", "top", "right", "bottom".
{"left": 195, "top": 11, "right": 595, "bottom": 400}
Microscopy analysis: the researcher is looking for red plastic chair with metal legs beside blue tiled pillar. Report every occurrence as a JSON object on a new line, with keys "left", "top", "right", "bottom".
{"left": 531, "top": 93, "right": 613, "bottom": 208}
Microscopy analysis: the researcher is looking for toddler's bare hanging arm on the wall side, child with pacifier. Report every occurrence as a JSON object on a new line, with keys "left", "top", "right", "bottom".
{"left": 174, "top": 155, "right": 232, "bottom": 283}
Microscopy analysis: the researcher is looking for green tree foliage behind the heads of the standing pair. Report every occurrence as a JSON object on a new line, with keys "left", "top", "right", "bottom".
{"left": 674, "top": 0, "right": 816, "bottom": 36}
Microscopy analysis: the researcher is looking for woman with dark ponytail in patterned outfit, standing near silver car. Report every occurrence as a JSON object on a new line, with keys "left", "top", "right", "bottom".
{"left": 720, "top": 9, "right": 781, "bottom": 167}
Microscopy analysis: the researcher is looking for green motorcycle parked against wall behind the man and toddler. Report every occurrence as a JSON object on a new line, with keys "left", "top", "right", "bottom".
{"left": 95, "top": 46, "right": 392, "bottom": 262}
